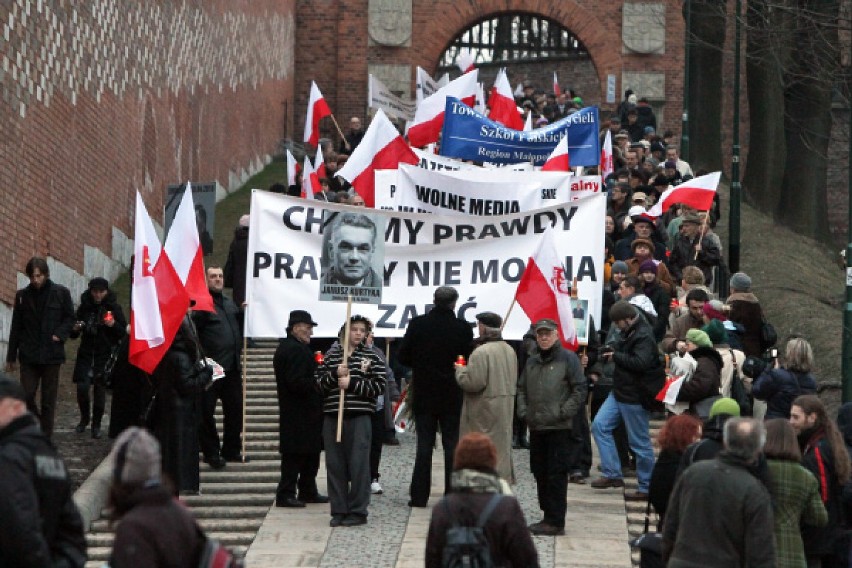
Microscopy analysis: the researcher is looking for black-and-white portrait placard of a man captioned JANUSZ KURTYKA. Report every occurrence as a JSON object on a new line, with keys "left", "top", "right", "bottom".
{"left": 319, "top": 209, "right": 385, "bottom": 304}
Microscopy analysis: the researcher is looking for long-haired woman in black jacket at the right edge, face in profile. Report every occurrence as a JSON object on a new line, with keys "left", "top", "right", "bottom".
{"left": 790, "top": 395, "right": 852, "bottom": 568}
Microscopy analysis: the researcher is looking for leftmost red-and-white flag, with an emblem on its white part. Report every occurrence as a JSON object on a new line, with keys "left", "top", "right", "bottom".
{"left": 128, "top": 192, "right": 189, "bottom": 373}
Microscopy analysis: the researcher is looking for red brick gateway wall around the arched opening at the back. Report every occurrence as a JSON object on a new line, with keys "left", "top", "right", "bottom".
{"left": 294, "top": 0, "right": 684, "bottom": 141}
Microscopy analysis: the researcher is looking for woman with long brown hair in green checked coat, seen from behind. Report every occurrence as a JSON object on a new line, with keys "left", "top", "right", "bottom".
{"left": 763, "top": 418, "right": 828, "bottom": 568}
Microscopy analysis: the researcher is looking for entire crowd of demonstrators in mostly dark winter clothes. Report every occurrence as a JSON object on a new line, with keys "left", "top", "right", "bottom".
{"left": 0, "top": 79, "right": 852, "bottom": 568}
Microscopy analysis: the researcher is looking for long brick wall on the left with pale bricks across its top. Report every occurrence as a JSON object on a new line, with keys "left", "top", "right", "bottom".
{"left": 0, "top": 0, "right": 295, "bottom": 303}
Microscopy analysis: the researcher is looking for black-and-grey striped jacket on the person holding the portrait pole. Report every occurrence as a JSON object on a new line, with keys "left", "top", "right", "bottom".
{"left": 316, "top": 344, "right": 387, "bottom": 416}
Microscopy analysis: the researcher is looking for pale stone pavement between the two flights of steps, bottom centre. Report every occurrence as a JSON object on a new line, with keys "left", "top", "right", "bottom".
{"left": 246, "top": 434, "right": 630, "bottom": 568}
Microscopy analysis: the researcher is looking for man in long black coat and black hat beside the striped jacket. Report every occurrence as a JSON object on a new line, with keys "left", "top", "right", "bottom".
{"left": 272, "top": 310, "right": 328, "bottom": 507}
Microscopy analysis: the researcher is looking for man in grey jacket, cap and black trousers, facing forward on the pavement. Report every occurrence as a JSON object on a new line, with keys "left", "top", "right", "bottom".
{"left": 518, "top": 319, "right": 586, "bottom": 536}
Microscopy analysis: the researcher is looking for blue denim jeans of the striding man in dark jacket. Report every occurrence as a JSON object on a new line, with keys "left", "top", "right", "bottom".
{"left": 592, "top": 393, "right": 654, "bottom": 493}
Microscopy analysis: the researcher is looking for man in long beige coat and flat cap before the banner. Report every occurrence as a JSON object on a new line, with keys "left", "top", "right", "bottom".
{"left": 456, "top": 312, "right": 518, "bottom": 483}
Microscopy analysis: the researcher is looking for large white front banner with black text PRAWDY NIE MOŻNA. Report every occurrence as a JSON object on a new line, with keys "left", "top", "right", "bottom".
{"left": 246, "top": 190, "right": 606, "bottom": 339}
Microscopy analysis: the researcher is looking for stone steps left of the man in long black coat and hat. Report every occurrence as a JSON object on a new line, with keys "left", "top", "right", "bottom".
{"left": 86, "top": 340, "right": 280, "bottom": 568}
